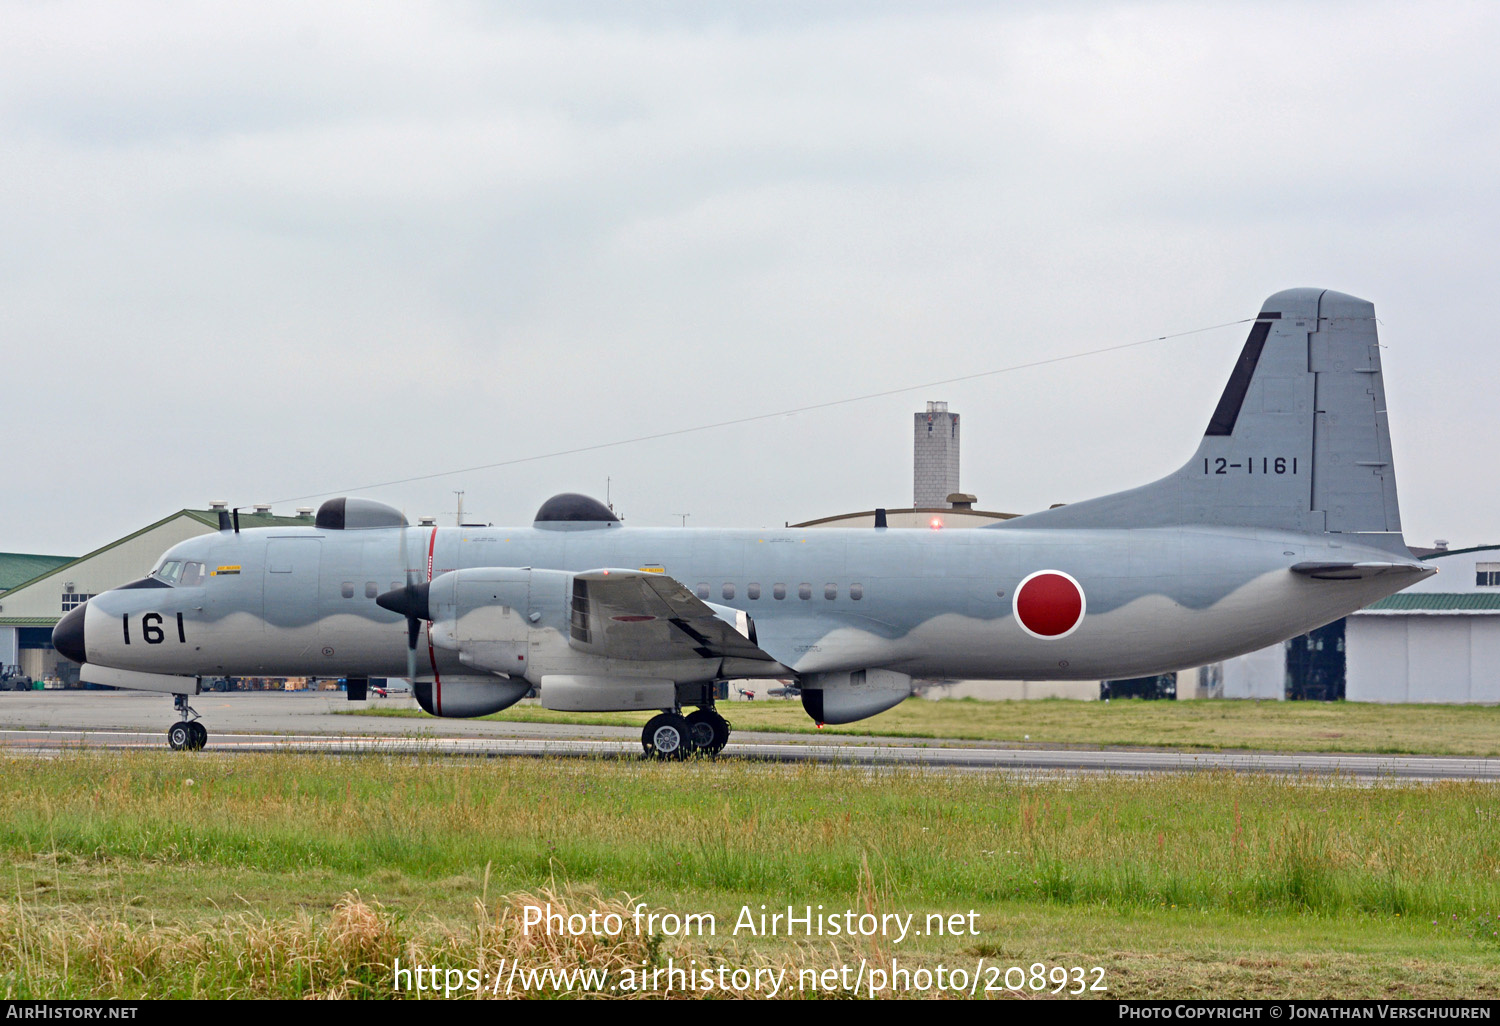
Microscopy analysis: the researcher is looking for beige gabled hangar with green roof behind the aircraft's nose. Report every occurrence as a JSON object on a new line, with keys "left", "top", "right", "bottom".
{"left": 0, "top": 507, "right": 312, "bottom": 684}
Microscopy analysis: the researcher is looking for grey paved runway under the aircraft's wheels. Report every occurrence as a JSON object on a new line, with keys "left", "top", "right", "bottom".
{"left": 0, "top": 692, "right": 1500, "bottom": 782}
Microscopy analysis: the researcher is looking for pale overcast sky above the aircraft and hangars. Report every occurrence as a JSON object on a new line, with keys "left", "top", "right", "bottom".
{"left": 0, "top": 0, "right": 1500, "bottom": 555}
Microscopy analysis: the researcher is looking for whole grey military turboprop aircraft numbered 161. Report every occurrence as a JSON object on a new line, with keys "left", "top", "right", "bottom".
{"left": 53, "top": 288, "right": 1433, "bottom": 758}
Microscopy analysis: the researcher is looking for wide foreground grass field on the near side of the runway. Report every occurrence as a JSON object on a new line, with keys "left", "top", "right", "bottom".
{"left": 0, "top": 752, "right": 1500, "bottom": 998}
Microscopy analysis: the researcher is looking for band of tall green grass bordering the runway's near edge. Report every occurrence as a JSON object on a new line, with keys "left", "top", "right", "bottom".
{"left": 0, "top": 753, "right": 1500, "bottom": 915}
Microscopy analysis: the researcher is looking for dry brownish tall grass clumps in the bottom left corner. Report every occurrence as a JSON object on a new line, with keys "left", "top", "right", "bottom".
{"left": 0, "top": 890, "right": 720, "bottom": 999}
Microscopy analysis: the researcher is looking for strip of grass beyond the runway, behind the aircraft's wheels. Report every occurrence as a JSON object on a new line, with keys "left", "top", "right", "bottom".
{"left": 350, "top": 699, "right": 1500, "bottom": 758}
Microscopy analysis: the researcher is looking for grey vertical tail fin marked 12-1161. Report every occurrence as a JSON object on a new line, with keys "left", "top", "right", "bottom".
{"left": 1005, "top": 288, "right": 1404, "bottom": 548}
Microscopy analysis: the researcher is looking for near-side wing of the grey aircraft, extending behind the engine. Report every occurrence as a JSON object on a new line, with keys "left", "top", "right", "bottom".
{"left": 569, "top": 570, "right": 776, "bottom": 666}
